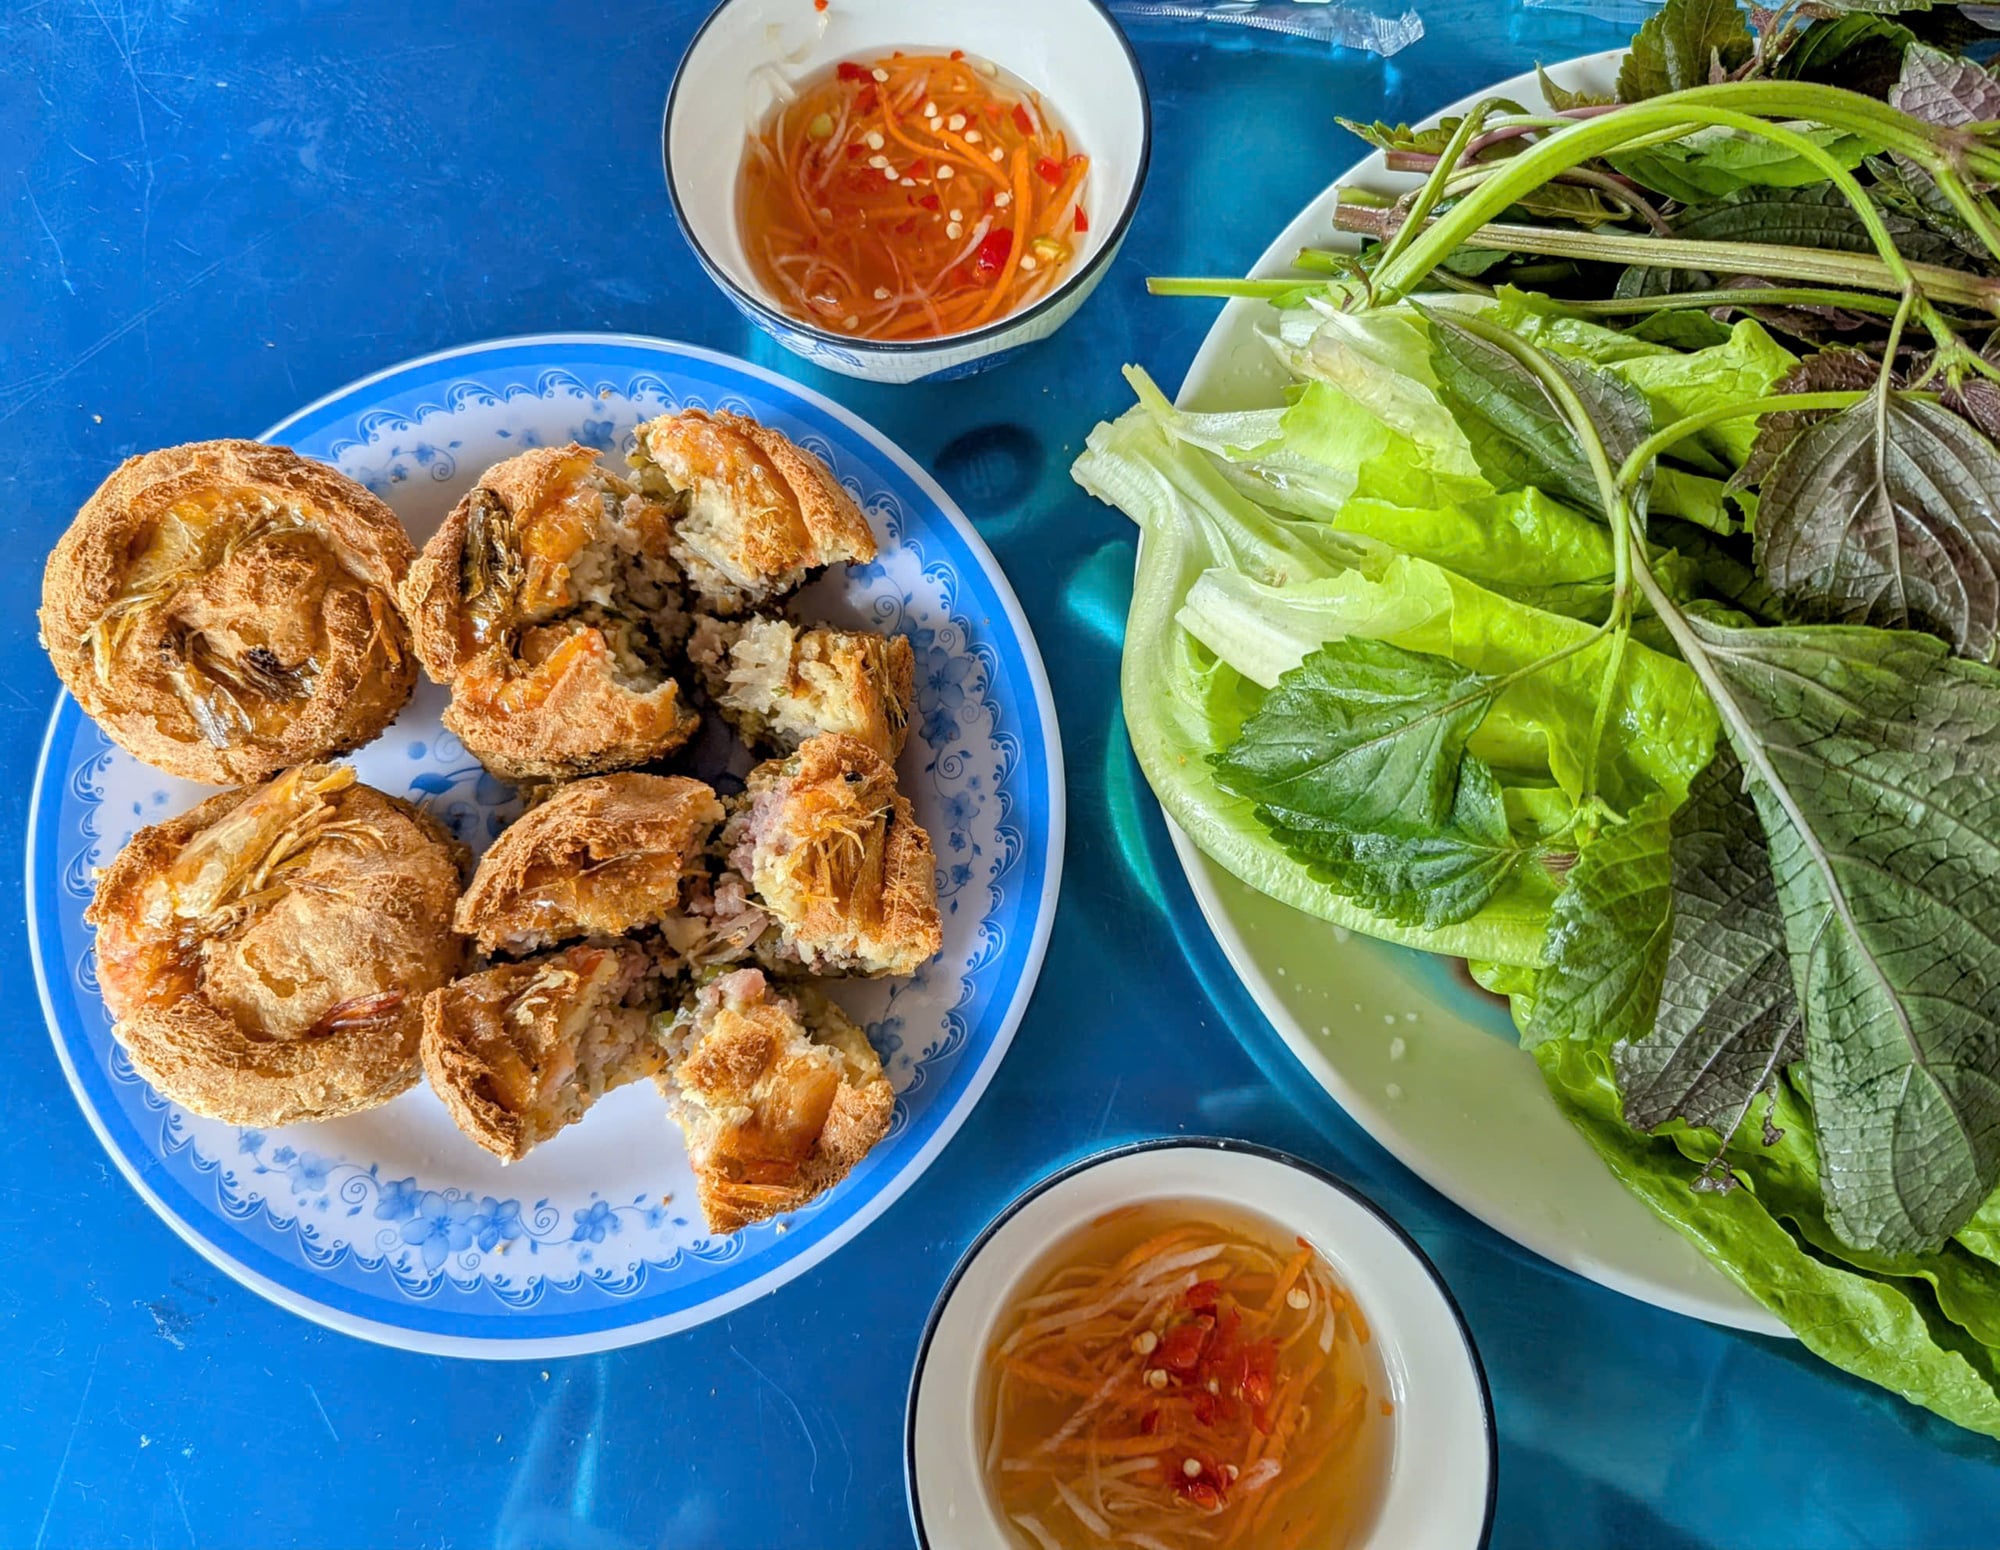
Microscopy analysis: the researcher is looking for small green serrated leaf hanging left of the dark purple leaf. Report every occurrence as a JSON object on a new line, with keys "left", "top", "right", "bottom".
{"left": 1522, "top": 794, "right": 1680, "bottom": 1048}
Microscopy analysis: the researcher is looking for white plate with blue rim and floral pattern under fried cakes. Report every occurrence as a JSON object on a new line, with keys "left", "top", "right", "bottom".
{"left": 26, "top": 334, "right": 1064, "bottom": 1358}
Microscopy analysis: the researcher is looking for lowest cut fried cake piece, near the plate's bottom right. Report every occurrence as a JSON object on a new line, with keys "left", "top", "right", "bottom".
{"left": 658, "top": 968, "right": 896, "bottom": 1232}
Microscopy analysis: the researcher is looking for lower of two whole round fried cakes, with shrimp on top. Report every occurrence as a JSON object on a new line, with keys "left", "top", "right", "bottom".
{"left": 84, "top": 766, "right": 466, "bottom": 1126}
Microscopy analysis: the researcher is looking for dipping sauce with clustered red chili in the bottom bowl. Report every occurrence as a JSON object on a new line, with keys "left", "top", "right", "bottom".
{"left": 982, "top": 1206, "right": 1392, "bottom": 1550}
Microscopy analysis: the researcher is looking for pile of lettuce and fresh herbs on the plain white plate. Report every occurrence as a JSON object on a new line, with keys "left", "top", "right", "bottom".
{"left": 1076, "top": 0, "right": 2000, "bottom": 1436}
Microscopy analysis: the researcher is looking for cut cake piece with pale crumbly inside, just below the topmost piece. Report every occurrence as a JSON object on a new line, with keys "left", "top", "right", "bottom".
{"left": 688, "top": 616, "right": 916, "bottom": 760}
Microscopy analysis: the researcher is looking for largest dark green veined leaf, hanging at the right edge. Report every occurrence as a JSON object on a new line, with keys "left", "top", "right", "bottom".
{"left": 1688, "top": 620, "right": 2000, "bottom": 1252}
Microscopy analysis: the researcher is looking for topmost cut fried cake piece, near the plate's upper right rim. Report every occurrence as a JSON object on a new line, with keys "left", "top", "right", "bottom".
{"left": 632, "top": 410, "right": 876, "bottom": 614}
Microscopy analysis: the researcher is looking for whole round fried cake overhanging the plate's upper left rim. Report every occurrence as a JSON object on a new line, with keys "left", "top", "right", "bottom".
{"left": 42, "top": 442, "right": 416, "bottom": 784}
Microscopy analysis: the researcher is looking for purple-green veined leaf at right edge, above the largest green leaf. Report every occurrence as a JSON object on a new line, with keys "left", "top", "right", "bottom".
{"left": 1756, "top": 390, "right": 2000, "bottom": 658}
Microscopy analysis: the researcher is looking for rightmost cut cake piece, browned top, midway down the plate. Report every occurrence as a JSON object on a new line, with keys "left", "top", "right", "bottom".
{"left": 726, "top": 734, "right": 944, "bottom": 974}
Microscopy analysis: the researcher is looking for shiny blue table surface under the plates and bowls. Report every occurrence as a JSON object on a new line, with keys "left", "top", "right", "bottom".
{"left": 11, "top": 0, "right": 2000, "bottom": 1550}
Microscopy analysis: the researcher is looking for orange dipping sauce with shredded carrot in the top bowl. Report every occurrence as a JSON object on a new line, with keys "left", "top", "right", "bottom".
{"left": 736, "top": 50, "right": 1090, "bottom": 340}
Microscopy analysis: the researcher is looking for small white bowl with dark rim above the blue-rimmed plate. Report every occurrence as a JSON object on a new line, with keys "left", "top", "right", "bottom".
{"left": 662, "top": 0, "right": 1152, "bottom": 382}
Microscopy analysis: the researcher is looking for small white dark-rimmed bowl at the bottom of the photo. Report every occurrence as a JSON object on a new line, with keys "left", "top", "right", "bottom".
{"left": 904, "top": 1138, "right": 1498, "bottom": 1550}
